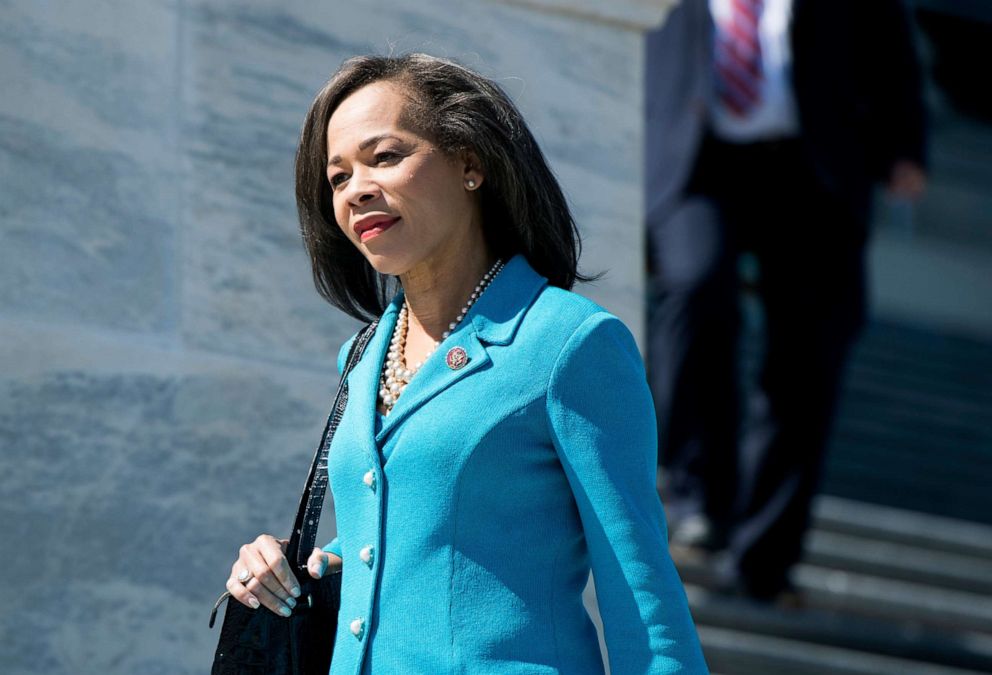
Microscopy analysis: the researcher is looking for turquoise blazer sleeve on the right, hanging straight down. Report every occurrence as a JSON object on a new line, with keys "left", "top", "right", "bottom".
{"left": 547, "top": 312, "right": 709, "bottom": 675}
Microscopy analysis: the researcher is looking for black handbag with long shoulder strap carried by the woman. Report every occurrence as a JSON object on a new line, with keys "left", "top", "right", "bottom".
{"left": 210, "top": 322, "right": 377, "bottom": 675}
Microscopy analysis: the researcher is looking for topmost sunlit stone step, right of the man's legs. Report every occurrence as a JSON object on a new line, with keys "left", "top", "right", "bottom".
{"left": 814, "top": 496, "right": 992, "bottom": 564}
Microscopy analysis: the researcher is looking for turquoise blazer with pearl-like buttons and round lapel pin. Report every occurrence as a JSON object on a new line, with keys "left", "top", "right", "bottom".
{"left": 326, "top": 256, "right": 708, "bottom": 675}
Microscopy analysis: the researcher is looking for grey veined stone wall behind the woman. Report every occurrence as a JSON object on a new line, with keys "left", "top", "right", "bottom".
{"left": 0, "top": 0, "right": 664, "bottom": 674}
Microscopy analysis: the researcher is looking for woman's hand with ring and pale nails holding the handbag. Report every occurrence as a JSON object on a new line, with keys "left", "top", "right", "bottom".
{"left": 227, "top": 534, "right": 341, "bottom": 616}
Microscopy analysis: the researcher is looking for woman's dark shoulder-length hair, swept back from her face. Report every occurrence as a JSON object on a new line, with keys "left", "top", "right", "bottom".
{"left": 296, "top": 54, "right": 587, "bottom": 320}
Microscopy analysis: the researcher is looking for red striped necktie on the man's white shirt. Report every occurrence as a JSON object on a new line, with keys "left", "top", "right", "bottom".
{"left": 715, "top": 0, "right": 764, "bottom": 117}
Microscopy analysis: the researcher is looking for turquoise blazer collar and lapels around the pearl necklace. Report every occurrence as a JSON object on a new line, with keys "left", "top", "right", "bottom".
{"left": 360, "top": 255, "right": 547, "bottom": 448}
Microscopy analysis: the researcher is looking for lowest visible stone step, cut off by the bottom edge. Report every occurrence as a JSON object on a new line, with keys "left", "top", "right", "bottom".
{"left": 699, "top": 626, "right": 981, "bottom": 675}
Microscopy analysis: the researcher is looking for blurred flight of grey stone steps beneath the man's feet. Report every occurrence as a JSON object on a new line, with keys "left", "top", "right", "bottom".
{"left": 673, "top": 497, "right": 992, "bottom": 675}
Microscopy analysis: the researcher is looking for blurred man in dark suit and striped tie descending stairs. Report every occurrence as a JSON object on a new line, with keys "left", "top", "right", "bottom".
{"left": 645, "top": 0, "right": 926, "bottom": 600}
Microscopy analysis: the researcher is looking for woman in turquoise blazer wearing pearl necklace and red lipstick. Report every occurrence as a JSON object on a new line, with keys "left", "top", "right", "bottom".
{"left": 227, "top": 54, "right": 706, "bottom": 675}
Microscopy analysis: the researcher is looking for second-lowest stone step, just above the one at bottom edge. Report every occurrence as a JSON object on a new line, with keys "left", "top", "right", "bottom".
{"left": 686, "top": 584, "right": 992, "bottom": 672}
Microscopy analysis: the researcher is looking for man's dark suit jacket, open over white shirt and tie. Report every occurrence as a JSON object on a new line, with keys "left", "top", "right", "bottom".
{"left": 645, "top": 0, "right": 926, "bottom": 224}
